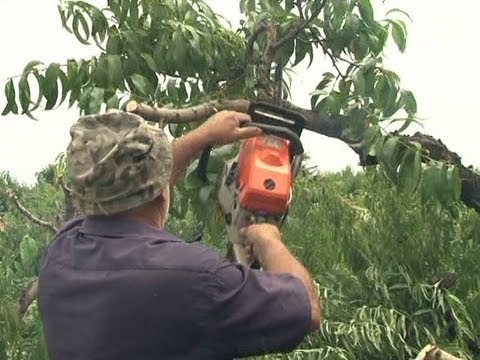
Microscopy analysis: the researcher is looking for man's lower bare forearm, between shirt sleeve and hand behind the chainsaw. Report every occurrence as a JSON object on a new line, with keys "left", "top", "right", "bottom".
{"left": 259, "top": 241, "right": 320, "bottom": 330}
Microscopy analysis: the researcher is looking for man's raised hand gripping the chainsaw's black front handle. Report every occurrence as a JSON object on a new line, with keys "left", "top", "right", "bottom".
{"left": 194, "top": 111, "right": 262, "bottom": 145}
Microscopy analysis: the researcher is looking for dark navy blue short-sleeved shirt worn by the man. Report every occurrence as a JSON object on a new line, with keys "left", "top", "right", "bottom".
{"left": 39, "top": 217, "right": 311, "bottom": 360}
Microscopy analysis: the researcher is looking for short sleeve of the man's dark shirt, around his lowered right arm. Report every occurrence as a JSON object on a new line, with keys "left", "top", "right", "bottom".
{"left": 207, "top": 264, "right": 311, "bottom": 356}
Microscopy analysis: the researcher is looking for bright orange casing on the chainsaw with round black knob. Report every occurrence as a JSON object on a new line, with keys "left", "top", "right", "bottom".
{"left": 237, "top": 135, "right": 292, "bottom": 215}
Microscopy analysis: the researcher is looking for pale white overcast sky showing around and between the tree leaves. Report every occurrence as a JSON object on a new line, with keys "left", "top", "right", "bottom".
{"left": 0, "top": 0, "right": 480, "bottom": 183}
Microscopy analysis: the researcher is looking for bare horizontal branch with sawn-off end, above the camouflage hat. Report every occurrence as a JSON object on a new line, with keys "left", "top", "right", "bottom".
{"left": 127, "top": 99, "right": 250, "bottom": 124}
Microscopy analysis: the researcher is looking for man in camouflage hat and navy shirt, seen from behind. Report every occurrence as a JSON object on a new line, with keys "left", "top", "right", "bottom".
{"left": 39, "top": 112, "right": 319, "bottom": 360}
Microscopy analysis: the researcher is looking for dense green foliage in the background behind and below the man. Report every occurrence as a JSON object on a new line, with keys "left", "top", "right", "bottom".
{"left": 0, "top": 171, "right": 480, "bottom": 359}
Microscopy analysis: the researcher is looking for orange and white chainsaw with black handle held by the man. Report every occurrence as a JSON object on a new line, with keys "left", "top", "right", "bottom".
{"left": 198, "top": 102, "right": 306, "bottom": 267}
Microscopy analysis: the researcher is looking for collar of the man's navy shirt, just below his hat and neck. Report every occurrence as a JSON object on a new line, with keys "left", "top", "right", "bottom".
{"left": 79, "top": 216, "right": 182, "bottom": 241}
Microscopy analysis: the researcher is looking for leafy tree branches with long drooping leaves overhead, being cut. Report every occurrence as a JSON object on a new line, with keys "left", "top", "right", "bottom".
{"left": 2, "top": 0, "right": 480, "bottom": 210}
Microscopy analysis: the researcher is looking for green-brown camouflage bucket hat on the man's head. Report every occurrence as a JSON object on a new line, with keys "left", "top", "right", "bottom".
{"left": 67, "top": 111, "right": 172, "bottom": 215}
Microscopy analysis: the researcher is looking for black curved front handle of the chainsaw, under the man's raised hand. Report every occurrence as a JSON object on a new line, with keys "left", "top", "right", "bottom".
{"left": 196, "top": 122, "right": 304, "bottom": 183}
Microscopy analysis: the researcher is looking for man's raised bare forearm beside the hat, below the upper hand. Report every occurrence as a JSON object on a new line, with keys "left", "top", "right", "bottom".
{"left": 170, "top": 129, "right": 209, "bottom": 187}
